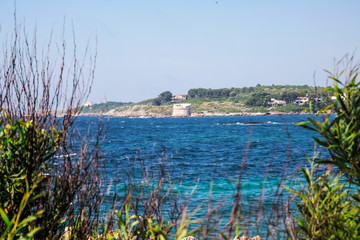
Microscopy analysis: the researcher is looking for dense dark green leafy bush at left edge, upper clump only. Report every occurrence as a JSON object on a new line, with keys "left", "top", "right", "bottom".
{"left": 0, "top": 118, "right": 61, "bottom": 235}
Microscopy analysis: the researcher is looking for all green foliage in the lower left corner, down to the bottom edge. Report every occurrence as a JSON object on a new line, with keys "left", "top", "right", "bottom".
{"left": 0, "top": 117, "right": 103, "bottom": 239}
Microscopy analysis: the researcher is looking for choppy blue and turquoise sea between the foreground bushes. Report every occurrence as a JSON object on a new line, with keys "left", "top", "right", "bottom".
{"left": 77, "top": 115, "right": 326, "bottom": 236}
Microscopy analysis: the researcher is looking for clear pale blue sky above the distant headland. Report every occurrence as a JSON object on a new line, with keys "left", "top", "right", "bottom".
{"left": 0, "top": 0, "right": 360, "bottom": 102}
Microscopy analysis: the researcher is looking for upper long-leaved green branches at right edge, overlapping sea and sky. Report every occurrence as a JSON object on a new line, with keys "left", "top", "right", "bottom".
{"left": 300, "top": 57, "right": 360, "bottom": 186}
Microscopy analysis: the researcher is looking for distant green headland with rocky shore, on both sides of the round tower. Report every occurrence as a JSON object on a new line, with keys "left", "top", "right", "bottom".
{"left": 82, "top": 84, "right": 328, "bottom": 117}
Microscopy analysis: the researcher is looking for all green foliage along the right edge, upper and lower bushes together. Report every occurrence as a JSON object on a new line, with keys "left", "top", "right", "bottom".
{"left": 288, "top": 58, "right": 360, "bottom": 239}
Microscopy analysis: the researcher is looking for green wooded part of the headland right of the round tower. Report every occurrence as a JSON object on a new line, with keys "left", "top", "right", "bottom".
{"left": 167, "top": 84, "right": 331, "bottom": 113}
